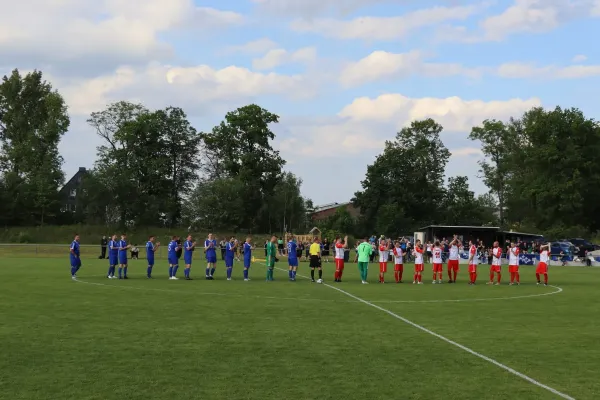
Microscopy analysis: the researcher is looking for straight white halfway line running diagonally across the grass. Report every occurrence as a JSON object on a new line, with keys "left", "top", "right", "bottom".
{"left": 277, "top": 268, "right": 575, "bottom": 400}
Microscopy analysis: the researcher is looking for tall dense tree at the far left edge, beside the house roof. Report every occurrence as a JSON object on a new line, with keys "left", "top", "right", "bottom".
{"left": 0, "top": 69, "right": 70, "bottom": 225}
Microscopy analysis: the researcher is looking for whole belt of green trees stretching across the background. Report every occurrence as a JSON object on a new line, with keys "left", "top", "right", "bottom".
{"left": 0, "top": 70, "right": 600, "bottom": 241}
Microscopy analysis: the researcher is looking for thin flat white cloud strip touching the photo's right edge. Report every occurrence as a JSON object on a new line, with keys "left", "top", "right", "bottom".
{"left": 497, "top": 63, "right": 600, "bottom": 79}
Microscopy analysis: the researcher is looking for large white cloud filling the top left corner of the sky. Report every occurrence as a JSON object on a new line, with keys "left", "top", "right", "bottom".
{"left": 0, "top": 0, "right": 244, "bottom": 63}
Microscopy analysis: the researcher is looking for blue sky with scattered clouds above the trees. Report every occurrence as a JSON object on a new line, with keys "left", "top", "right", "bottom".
{"left": 0, "top": 0, "right": 600, "bottom": 205}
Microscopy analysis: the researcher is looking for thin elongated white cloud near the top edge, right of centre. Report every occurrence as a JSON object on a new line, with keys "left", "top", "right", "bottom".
{"left": 291, "top": 5, "right": 482, "bottom": 40}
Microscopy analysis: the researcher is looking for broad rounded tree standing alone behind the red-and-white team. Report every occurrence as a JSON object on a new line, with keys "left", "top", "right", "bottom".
{"left": 352, "top": 119, "right": 450, "bottom": 234}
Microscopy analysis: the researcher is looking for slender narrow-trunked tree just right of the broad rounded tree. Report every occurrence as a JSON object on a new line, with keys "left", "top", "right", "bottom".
{"left": 469, "top": 120, "right": 510, "bottom": 226}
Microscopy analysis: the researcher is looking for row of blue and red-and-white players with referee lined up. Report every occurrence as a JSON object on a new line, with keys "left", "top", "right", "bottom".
{"left": 69, "top": 234, "right": 550, "bottom": 285}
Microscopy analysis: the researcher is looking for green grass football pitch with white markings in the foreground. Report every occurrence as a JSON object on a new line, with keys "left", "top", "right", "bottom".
{"left": 0, "top": 257, "right": 600, "bottom": 400}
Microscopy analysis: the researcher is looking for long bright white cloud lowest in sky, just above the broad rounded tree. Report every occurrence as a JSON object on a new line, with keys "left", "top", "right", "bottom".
{"left": 338, "top": 94, "right": 541, "bottom": 132}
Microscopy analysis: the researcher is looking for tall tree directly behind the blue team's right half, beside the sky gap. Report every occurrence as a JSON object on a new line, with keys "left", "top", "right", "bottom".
{"left": 201, "top": 104, "right": 285, "bottom": 230}
